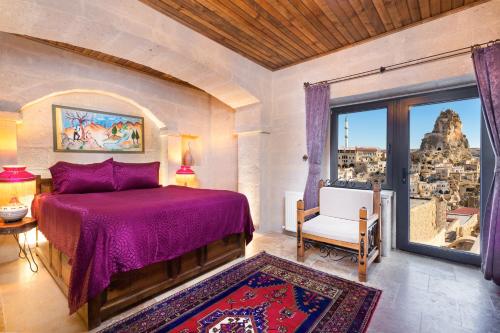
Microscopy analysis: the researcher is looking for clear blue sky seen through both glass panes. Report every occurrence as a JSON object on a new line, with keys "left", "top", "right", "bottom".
{"left": 338, "top": 98, "right": 481, "bottom": 149}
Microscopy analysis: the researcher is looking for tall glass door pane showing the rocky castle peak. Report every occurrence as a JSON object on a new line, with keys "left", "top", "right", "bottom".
{"left": 409, "top": 97, "right": 481, "bottom": 254}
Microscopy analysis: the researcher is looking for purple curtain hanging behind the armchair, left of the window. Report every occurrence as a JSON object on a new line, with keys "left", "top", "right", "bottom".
{"left": 304, "top": 84, "right": 330, "bottom": 209}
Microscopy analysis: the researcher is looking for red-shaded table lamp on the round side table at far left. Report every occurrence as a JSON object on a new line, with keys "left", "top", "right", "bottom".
{"left": 0, "top": 165, "right": 35, "bottom": 222}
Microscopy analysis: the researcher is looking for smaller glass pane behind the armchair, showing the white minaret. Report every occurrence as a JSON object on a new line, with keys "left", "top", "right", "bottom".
{"left": 331, "top": 107, "right": 388, "bottom": 185}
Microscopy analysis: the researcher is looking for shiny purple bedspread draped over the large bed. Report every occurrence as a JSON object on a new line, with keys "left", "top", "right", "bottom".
{"left": 33, "top": 186, "right": 254, "bottom": 313}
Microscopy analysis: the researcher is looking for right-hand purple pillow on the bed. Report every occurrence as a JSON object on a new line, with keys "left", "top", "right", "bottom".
{"left": 113, "top": 161, "right": 160, "bottom": 191}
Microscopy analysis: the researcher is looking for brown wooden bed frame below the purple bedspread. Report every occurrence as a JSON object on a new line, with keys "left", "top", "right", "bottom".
{"left": 36, "top": 176, "right": 245, "bottom": 330}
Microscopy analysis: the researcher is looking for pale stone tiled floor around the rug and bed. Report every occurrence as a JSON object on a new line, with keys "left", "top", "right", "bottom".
{"left": 0, "top": 233, "right": 500, "bottom": 333}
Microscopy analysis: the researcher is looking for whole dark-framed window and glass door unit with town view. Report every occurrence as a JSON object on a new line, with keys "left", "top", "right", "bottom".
{"left": 330, "top": 87, "right": 495, "bottom": 265}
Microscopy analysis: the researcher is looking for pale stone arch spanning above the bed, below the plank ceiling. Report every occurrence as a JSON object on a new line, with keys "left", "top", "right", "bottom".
{"left": 0, "top": 0, "right": 271, "bottom": 108}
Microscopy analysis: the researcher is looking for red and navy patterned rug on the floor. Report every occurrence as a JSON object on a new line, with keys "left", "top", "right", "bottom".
{"left": 101, "top": 253, "right": 382, "bottom": 333}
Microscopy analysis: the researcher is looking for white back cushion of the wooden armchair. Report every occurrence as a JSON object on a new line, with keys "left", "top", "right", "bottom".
{"left": 319, "top": 187, "right": 373, "bottom": 220}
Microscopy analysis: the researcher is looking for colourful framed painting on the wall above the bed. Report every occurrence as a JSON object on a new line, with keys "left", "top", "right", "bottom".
{"left": 52, "top": 105, "right": 144, "bottom": 153}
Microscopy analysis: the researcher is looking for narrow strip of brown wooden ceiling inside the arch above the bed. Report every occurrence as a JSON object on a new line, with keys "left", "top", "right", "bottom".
{"left": 17, "top": 35, "right": 201, "bottom": 90}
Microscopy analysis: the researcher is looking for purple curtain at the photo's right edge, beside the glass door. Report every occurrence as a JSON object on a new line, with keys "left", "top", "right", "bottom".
{"left": 472, "top": 43, "right": 500, "bottom": 285}
